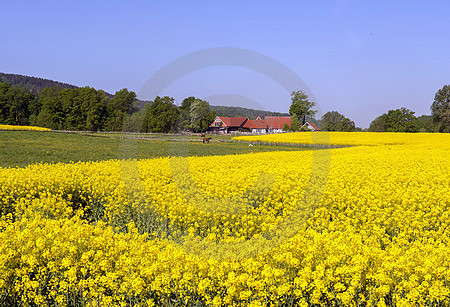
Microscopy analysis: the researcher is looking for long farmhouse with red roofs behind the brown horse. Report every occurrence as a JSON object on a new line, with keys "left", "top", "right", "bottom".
{"left": 209, "top": 116, "right": 291, "bottom": 134}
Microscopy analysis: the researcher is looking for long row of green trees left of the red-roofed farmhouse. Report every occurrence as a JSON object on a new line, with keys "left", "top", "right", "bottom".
{"left": 0, "top": 82, "right": 216, "bottom": 132}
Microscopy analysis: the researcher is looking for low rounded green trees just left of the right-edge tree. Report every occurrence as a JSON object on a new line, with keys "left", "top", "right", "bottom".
{"left": 369, "top": 108, "right": 419, "bottom": 132}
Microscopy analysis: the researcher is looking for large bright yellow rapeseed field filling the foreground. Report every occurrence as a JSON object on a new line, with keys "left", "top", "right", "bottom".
{"left": 0, "top": 133, "right": 450, "bottom": 306}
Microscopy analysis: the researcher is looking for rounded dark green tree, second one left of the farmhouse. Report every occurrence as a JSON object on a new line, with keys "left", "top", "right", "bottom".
{"left": 142, "top": 96, "right": 180, "bottom": 133}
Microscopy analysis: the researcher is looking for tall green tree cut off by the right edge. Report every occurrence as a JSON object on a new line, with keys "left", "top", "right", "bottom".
{"left": 431, "top": 85, "right": 450, "bottom": 132}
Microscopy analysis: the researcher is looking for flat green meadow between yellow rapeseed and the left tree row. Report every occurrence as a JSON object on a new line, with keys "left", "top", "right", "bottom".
{"left": 0, "top": 131, "right": 311, "bottom": 167}
